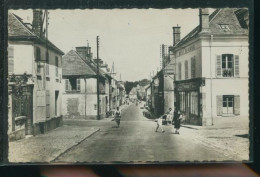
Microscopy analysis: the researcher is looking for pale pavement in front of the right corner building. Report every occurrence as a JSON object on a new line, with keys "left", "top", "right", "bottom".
{"left": 180, "top": 117, "right": 249, "bottom": 161}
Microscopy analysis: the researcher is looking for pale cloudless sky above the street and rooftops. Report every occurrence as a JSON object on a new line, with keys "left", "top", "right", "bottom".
{"left": 10, "top": 9, "right": 211, "bottom": 81}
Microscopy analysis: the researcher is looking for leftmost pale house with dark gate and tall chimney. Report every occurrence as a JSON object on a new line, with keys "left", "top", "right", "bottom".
{"left": 8, "top": 10, "right": 64, "bottom": 140}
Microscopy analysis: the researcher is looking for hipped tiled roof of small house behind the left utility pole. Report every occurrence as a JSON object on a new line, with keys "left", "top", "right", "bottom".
{"left": 62, "top": 50, "right": 96, "bottom": 77}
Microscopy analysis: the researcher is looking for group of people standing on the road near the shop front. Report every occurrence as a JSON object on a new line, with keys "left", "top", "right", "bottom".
{"left": 155, "top": 108, "right": 182, "bottom": 134}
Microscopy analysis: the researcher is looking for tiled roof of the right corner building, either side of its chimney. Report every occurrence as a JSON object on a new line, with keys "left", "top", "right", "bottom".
{"left": 174, "top": 8, "right": 248, "bottom": 48}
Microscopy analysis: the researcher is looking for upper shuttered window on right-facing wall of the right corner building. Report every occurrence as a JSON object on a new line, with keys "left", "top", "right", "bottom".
{"left": 216, "top": 54, "right": 239, "bottom": 77}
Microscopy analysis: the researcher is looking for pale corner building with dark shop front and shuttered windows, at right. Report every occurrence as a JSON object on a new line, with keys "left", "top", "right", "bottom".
{"left": 170, "top": 9, "right": 249, "bottom": 125}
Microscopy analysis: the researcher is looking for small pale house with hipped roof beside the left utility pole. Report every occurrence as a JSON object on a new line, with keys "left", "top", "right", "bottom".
{"left": 62, "top": 46, "right": 109, "bottom": 119}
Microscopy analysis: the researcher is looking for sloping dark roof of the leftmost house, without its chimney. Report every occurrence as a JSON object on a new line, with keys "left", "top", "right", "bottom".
{"left": 8, "top": 13, "right": 64, "bottom": 55}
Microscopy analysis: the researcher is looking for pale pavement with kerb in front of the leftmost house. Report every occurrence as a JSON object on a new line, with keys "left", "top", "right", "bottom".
{"left": 9, "top": 125, "right": 99, "bottom": 163}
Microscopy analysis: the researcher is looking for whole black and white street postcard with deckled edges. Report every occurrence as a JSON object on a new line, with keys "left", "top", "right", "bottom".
{"left": 7, "top": 8, "right": 252, "bottom": 164}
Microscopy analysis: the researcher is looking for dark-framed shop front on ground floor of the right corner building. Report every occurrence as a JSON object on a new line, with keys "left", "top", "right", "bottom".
{"left": 175, "top": 78, "right": 205, "bottom": 125}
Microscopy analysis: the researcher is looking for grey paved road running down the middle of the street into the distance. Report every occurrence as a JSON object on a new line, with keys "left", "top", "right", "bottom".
{"left": 56, "top": 104, "right": 232, "bottom": 163}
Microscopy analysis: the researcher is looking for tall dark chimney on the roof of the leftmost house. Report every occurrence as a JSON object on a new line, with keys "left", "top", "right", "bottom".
{"left": 32, "top": 9, "right": 43, "bottom": 37}
